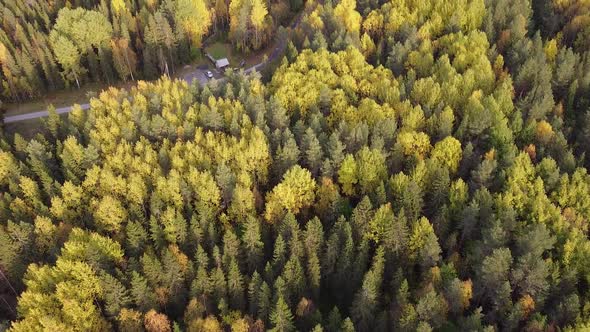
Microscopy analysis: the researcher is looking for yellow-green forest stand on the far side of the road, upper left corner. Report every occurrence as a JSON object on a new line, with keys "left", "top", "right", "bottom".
{"left": 0, "top": 0, "right": 302, "bottom": 102}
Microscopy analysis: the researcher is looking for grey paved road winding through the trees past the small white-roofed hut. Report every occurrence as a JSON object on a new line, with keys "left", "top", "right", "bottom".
{"left": 4, "top": 8, "right": 303, "bottom": 123}
